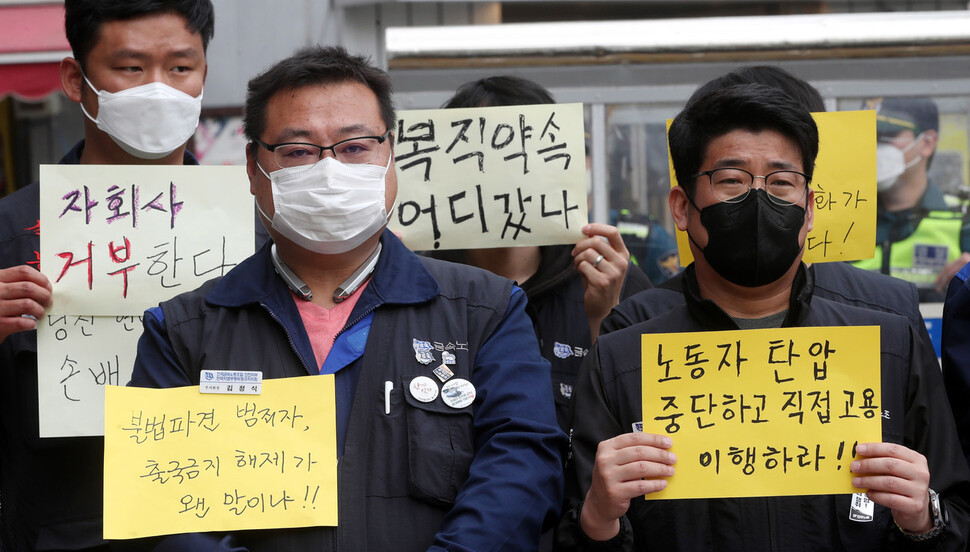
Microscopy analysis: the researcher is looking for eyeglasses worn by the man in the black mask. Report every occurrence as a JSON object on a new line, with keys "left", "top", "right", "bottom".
{"left": 691, "top": 167, "right": 809, "bottom": 206}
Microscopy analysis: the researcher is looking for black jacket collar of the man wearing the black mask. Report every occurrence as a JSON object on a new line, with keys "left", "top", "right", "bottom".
{"left": 682, "top": 263, "right": 815, "bottom": 330}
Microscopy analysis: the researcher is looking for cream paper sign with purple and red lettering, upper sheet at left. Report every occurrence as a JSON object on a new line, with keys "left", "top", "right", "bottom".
{"left": 40, "top": 165, "right": 256, "bottom": 316}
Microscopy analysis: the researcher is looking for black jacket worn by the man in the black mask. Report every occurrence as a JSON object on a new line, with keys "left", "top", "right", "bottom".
{"left": 559, "top": 267, "right": 970, "bottom": 552}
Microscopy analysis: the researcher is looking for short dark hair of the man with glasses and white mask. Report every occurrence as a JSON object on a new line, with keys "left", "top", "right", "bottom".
{"left": 243, "top": 46, "right": 397, "bottom": 142}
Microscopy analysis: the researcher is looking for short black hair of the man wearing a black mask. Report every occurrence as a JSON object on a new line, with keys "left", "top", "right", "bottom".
{"left": 667, "top": 84, "right": 818, "bottom": 196}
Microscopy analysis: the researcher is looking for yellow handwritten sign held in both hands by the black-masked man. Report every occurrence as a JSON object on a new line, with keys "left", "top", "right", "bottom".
{"left": 641, "top": 326, "right": 882, "bottom": 499}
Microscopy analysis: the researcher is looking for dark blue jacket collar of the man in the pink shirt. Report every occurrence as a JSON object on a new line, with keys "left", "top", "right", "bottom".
{"left": 206, "top": 230, "right": 440, "bottom": 310}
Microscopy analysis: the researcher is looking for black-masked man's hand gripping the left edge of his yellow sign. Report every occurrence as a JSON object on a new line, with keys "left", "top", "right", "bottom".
{"left": 579, "top": 433, "right": 677, "bottom": 540}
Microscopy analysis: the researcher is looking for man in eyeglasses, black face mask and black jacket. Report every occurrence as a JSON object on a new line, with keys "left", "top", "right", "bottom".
{"left": 559, "top": 84, "right": 970, "bottom": 552}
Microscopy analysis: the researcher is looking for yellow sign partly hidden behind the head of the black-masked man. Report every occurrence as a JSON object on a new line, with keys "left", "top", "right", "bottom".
{"left": 667, "top": 111, "right": 876, "bottom": 266}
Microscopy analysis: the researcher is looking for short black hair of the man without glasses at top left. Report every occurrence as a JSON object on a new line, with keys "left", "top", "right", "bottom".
{"left": 64, "top": 0, "right": 216, "bottom": 68}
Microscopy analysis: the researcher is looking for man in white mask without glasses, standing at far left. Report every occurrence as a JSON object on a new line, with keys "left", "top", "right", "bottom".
{"left": 0, "top": 0, "right": 215, "bottom": 551}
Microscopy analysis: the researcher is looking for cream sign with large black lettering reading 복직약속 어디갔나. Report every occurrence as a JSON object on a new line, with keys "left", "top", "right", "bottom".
{"left": 390, "top": 104, "right": 588, "bottom": 250}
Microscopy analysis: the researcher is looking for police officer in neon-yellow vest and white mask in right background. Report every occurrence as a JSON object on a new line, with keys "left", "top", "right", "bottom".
{"left": 855, "top": 98, "right": 970, "bottom": 301}
